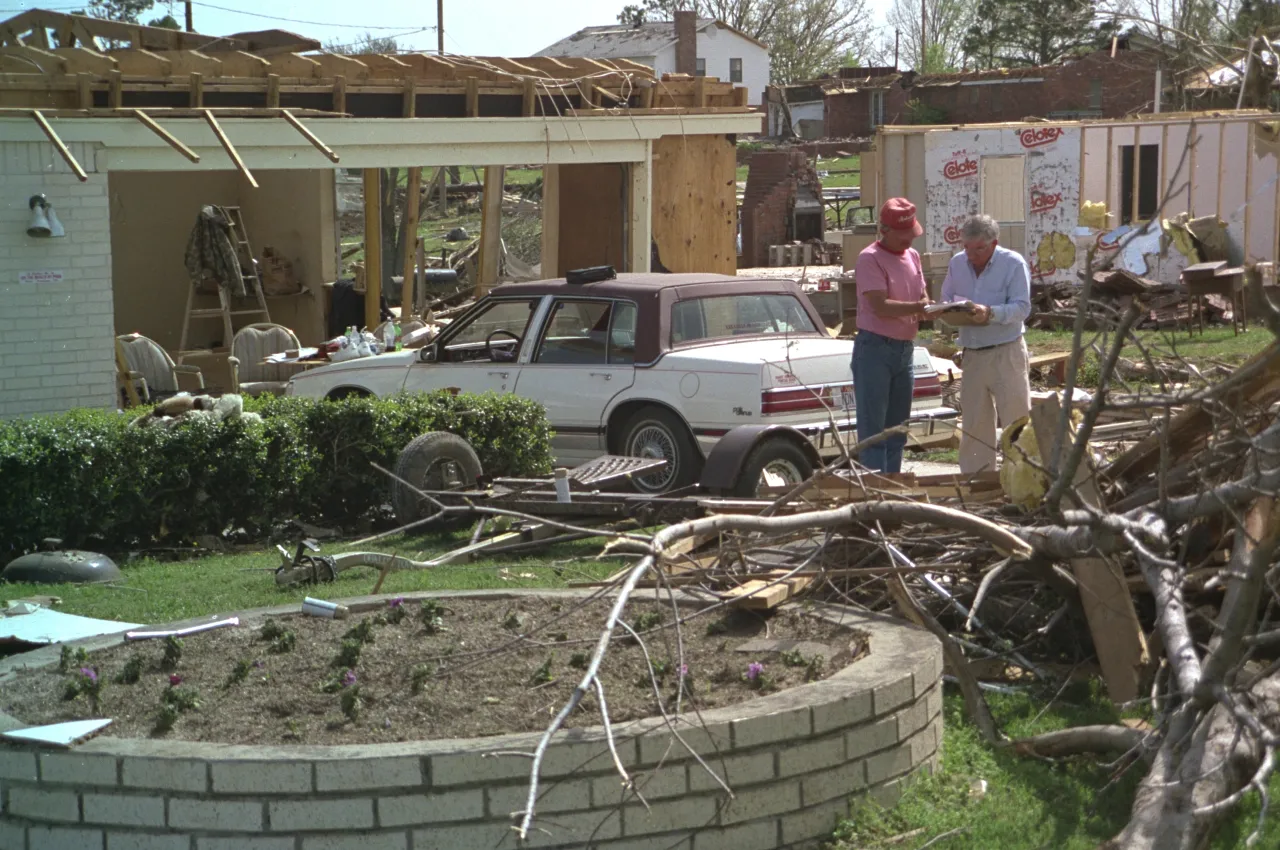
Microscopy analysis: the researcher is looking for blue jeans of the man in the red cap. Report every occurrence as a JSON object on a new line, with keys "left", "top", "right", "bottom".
{"left": 852, "top": 330, "right": 915, "bottom": 472}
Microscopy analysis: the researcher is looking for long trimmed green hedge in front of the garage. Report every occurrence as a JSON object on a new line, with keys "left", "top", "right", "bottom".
{"left": 0, "top": 392, "right": 552, "bottom": 566}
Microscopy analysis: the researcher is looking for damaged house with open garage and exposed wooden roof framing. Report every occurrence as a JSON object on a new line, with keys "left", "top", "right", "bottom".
{"left": 0, "top": 10, "right": 760, "bottom": 417}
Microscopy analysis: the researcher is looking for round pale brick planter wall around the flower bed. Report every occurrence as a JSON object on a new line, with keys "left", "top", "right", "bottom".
{"left": 0, "top": 591, "right": 942, "bottom": 850}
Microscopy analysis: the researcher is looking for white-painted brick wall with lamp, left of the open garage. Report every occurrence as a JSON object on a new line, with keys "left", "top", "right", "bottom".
{"left": 0, "top": 142, "right": 115, "bottom": 417}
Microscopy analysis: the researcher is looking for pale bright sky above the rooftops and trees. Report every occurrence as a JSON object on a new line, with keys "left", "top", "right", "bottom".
{"left": 0, "top": 0, "right": 886, "bottom": 56}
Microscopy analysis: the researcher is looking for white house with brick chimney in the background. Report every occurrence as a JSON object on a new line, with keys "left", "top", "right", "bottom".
{"left": 535, "top": 18, "right": 769, "bottom": 106}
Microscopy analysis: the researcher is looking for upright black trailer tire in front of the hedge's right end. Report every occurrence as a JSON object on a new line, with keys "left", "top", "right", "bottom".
{"left": 392, "top": 431, "right": 484, "bottom": 531}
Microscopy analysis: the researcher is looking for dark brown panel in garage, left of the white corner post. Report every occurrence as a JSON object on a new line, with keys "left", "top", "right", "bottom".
{"left": 556, "top": 163, "right": 627, "bottom": 277}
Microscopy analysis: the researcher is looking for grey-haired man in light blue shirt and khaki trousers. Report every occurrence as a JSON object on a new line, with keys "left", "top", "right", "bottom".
{"left": 942, "top": 215, "right": 1032, "bottom": 472}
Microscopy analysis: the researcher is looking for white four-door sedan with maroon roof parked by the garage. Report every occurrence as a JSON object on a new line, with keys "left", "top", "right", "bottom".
{"left": 288, "top": 274, "right": 956, "bottom": 493}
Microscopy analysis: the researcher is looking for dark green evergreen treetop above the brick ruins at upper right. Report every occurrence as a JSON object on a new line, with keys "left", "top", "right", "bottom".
{"left": 963, "top": 0, "right": 1120, "bottom": 67}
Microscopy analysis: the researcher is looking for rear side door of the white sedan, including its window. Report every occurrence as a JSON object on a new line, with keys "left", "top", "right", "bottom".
{"left": 516, "top": 298, "right": 636, "bottom": 466}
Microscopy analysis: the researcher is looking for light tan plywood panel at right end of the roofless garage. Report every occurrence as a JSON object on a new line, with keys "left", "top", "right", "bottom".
{"left": 653, "top": 136, "right": 737, "bottom": 274}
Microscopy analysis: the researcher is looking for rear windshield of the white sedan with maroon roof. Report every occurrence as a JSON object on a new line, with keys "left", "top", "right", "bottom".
{"left": 671, "top": 294, "right": 818, "bottom": 346}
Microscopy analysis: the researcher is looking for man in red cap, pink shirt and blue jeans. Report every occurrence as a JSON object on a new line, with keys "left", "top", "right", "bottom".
{"left": 852, "top": 197, "right": 929, "bottom": 472}
